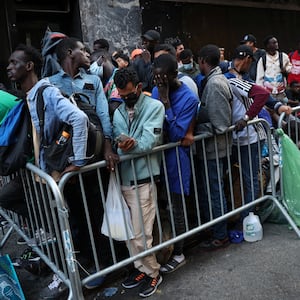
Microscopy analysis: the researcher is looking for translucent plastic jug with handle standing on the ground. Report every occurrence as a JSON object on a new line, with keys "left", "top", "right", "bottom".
{"left": 243, "top": 212, "right": 263, "bottom": 242}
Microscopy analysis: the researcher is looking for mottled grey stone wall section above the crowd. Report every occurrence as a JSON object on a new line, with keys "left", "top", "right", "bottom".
{"left": 79, "top": 0, "right": 142, "bottom": 51}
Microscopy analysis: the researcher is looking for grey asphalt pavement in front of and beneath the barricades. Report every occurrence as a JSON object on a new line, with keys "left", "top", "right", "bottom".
{"left": 2, "top": 223, "right": 300, "bottom": 300}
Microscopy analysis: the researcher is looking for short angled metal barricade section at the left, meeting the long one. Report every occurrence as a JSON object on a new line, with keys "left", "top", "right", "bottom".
{"left": 0, "top": 163, "right": 83, "bottom": 299}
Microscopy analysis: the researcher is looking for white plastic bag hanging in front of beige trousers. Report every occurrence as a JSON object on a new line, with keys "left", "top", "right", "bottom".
{"left": 101, "top": 172, "right": 134, "bottom": 241}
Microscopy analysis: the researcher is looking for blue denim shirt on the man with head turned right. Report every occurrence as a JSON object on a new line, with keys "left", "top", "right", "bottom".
{"left": 49, "top": 69, "right": 112, "bottom": 138}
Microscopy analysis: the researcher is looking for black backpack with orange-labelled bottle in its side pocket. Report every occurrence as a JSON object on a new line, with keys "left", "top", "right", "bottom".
{"left": 37, "top": 85, "right": 104, "bottom": 172}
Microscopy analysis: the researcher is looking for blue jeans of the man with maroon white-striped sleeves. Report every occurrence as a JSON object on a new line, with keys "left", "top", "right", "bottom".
{"left": 232, "top": 143, "right": 259, "bottom": 221}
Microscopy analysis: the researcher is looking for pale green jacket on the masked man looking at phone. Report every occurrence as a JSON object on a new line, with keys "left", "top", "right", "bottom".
{"left": 113, "top": 93, "right": 165, "bottom": 186}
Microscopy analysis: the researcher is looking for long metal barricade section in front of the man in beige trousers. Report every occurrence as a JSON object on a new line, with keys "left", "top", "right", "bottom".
{"left": 59, "top": 120, "right": 300, "bottom": 298}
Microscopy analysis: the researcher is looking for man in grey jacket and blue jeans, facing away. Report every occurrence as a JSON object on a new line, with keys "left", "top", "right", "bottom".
{"left": 197, "top": 45, "right": 232, "bottom": 250}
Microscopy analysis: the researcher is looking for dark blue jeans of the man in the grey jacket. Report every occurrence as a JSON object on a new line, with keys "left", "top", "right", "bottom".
{"left": 197, "top": 158, "right": 227, "bottom": 240}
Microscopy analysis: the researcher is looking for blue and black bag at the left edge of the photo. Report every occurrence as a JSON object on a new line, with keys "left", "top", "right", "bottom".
{"left": 0, "top": 100, "right": 33, "bottom": 176}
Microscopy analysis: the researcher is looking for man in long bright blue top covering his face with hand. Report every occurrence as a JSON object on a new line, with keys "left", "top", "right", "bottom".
{"left": 152, "top": 54, "right": 199, "bottom": 273}
